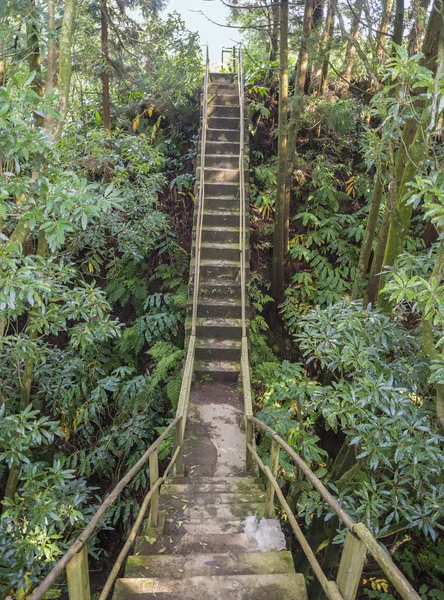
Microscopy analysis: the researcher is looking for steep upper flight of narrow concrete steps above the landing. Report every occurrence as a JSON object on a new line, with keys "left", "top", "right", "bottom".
{"left": 187, "top": 73, "right": 246, "bottom": 382}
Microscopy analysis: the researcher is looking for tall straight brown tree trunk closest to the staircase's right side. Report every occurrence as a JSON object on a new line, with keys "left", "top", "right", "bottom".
{"left": 272, "top": 0, "right": 289, "bottom": 310}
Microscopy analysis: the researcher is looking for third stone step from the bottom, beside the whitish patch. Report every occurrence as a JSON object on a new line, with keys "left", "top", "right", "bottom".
{"left": 135, "top": 533, "right": 259, "bottom": 555}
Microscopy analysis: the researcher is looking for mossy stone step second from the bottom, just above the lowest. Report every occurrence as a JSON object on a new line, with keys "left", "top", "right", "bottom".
{"left": 125, "top": 550, "right": 294, "bottom": 579}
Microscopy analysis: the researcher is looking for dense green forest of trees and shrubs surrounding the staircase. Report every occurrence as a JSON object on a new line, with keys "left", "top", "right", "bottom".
{"left": 0, "top": 0, "right": 444, "bottom": 600}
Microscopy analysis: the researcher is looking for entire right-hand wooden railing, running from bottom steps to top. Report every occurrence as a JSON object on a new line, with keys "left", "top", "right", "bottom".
{"left": 238, "top": 45, "right": 420, "bottom": 600}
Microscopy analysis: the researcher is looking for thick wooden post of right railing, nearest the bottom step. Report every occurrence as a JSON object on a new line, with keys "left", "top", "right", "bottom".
{"left": 336, "top": 531, "right": 367, "bottom": 600}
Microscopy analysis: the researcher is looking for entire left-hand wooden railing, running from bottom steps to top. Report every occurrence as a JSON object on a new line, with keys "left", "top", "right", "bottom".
{"left": 26, "top": 46, "right": 210, "bottom": 600}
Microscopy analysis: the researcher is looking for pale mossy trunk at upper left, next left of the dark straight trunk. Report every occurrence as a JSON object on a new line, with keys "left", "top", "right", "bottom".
{"left": 53, "top": 0, "right": 77, "bottom": 139}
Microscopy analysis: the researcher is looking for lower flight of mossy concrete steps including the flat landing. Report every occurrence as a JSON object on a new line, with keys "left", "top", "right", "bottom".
{"left": 113, "top": 383, "right": 307, "bottom": 600}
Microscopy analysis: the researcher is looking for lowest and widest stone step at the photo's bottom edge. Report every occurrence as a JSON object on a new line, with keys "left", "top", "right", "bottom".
{"left": 113, "top": 573, "right": 307, "bottom": 600}
